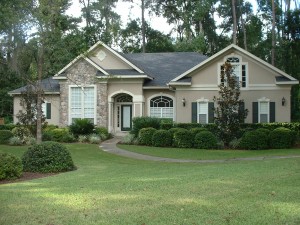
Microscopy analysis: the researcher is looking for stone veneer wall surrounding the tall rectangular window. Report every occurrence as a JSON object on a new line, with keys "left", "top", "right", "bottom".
{"left": 60, "top": 59, "right": 108, "bottom": 127}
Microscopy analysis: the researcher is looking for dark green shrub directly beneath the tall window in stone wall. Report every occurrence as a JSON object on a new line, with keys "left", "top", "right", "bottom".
{"left": 69, "top": 119, "right": 95, "bottom": 137}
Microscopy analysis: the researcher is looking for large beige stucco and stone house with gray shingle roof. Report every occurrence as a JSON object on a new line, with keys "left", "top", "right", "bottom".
{"left": 10, "top": 42, "right": 298, "bottom": 133}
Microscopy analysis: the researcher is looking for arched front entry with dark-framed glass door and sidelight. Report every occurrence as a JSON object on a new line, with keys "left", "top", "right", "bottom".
{"left": 114, "top": 93, "right": 132, "bottom": 131}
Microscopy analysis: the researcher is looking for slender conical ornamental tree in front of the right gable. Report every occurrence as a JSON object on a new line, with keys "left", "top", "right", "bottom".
{"left": 214, "top": 62, "right": 248, "bottom": 146}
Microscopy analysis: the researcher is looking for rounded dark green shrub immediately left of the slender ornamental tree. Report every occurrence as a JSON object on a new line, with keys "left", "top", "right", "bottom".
{"left": 194, "top": 131, "right": 218, "bottom": 149}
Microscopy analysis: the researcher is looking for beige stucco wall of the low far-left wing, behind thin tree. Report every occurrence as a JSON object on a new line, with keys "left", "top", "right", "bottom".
{"left": 13, "top": 95, "right": 60, "bottom": 125}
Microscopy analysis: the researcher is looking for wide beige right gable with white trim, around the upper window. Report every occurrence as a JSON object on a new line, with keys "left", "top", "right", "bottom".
{"left": 169, "top": 45, "right": 298, "bottom": 85}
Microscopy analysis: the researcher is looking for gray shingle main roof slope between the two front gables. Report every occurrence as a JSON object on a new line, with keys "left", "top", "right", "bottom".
{"left": 122, "top": 52, "right": 207, "bottom": 86}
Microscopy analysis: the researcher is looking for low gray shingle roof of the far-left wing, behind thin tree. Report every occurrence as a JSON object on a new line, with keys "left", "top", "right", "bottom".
{"left": 9, "top": 77, "right": 60, "bottom": 95}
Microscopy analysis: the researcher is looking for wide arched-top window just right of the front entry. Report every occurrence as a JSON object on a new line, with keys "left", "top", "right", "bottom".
{"left": 150, "top": 96, "right": 174, "bottom": 119}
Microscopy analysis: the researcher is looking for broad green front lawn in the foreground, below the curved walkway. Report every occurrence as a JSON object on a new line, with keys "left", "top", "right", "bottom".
{"left": 0, "top": 144, "right": 300, "bottom": 225}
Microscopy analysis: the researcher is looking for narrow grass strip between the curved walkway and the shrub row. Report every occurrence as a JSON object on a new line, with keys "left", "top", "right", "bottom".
{"left": 118, "top": 144, "right": 300, "bottom": 160}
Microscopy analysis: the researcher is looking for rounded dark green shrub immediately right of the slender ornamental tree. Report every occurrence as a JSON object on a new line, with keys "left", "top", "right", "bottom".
{"left": 239, "top": 130, "right": 269, "bottom": 150}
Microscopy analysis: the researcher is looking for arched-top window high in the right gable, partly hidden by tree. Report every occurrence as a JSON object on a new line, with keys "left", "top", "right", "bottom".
{"left": 221, "top": 57, "right": 247, "bottom": 88}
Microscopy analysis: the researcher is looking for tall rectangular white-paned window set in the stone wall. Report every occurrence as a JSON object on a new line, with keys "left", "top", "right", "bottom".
{"left": 70, "top": 87, "right": 95, "bottom": 123}
